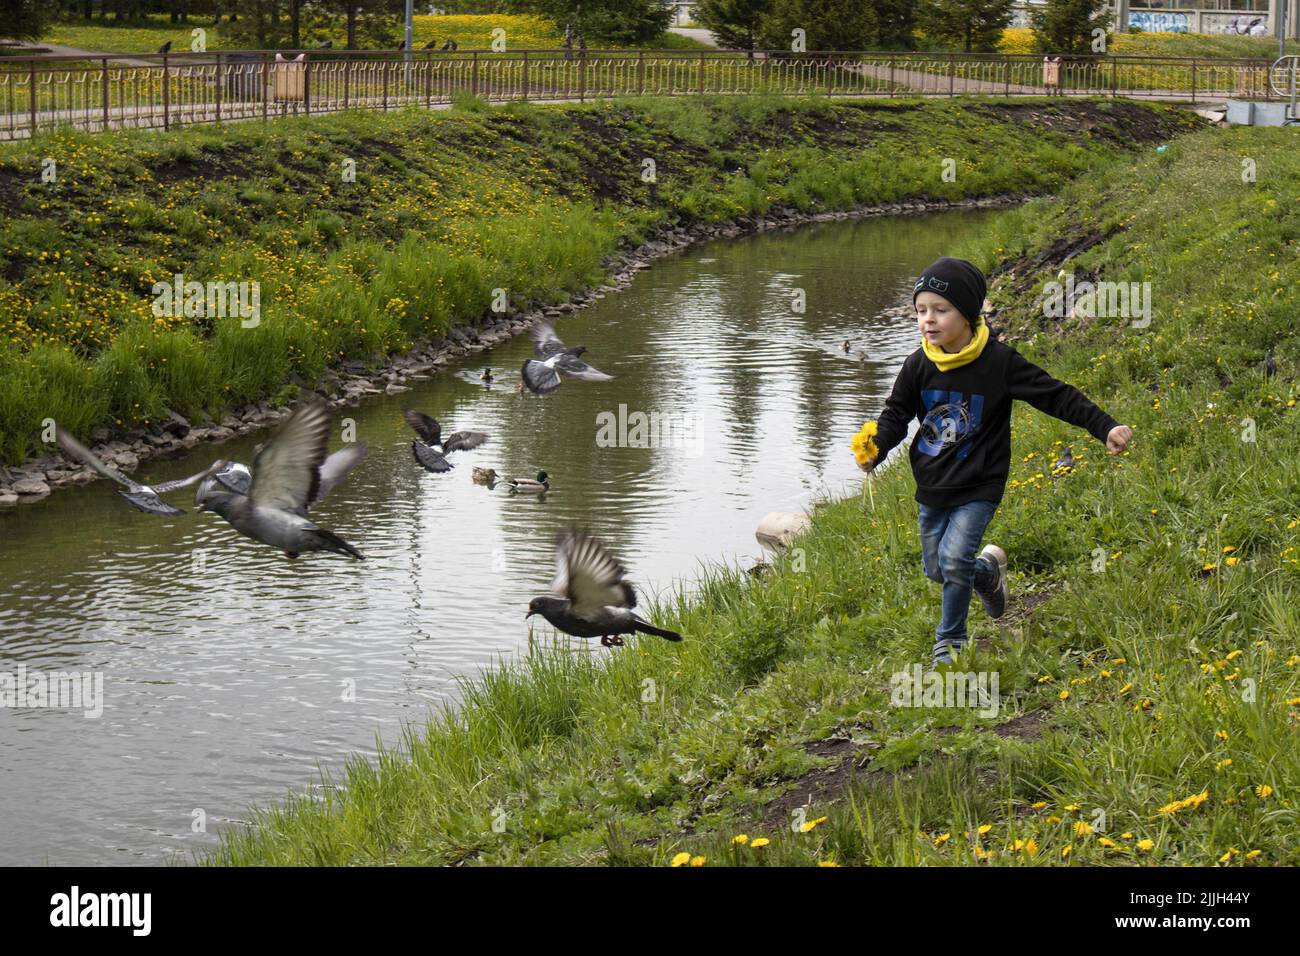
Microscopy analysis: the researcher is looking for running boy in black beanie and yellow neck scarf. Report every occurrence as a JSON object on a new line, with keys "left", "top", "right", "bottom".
{"left": 862, "top": 256, "right": 1132, "bottom": 666}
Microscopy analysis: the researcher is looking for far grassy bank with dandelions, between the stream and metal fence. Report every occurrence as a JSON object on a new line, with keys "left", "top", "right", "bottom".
{"left": 0, "top": 98, "right": 1197, "bottom": 463}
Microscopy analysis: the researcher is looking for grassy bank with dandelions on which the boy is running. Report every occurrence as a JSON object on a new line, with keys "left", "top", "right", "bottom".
{"left": 212, "top": 119, "right": 1300, "bottom": 866}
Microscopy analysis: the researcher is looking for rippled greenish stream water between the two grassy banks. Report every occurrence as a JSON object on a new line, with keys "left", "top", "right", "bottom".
{"left": 0, "top": 212, "right": 996, "bottom": 865}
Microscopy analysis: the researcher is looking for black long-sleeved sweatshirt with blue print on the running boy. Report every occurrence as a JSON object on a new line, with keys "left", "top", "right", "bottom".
{"left": 875, "top": 338, "right": 1119, "bottom": 507}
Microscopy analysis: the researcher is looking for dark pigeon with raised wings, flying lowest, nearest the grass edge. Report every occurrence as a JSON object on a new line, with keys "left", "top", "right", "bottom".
{"left": 524, "top": 531, "right": 681, "bottom": 648}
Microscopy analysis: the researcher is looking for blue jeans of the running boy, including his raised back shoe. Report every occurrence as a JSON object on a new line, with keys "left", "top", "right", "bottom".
{"left": 920, "top": 501, "right": 997, "bottom": 650}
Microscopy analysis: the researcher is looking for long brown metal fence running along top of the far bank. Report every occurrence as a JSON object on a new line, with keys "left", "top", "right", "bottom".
{"left": 0, "top": 49, "right": 1270, "bottom": 139}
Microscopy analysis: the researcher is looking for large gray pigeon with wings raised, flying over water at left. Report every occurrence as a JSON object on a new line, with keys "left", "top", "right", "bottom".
{"left": 194, "top": 401, "right": 365, "bottom": 558}
